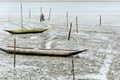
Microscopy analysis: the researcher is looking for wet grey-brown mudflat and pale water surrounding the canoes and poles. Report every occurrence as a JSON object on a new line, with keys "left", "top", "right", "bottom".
{"left": 0, "top": 2, "right": 120, "bottom": 80}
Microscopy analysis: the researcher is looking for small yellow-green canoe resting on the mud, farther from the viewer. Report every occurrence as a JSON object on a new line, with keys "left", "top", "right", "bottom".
{"left": 4, "top": 27, "right": 51, "bottom": 34}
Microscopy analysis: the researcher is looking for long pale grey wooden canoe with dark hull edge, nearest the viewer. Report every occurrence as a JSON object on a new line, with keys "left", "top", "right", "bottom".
{"left": 0, "top": 46, "right": 87, "bottom": 57}
